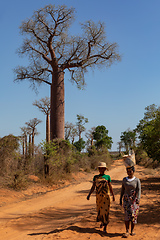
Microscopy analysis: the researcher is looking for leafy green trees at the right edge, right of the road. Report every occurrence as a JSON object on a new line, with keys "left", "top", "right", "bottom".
{"left": 118, "top": 104, "right": 160, "bottom": 162}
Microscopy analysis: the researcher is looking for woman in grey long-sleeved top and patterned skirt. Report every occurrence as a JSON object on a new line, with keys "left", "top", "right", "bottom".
{"left": 120, "top": 159, "right": 141, "bottom": 238}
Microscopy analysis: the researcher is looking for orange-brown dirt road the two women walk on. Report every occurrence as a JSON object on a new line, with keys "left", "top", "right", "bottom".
{"left": 0, "top": 160, "right": 160, "bottom": 240}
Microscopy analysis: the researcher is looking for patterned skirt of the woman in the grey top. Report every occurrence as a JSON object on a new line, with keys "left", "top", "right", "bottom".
{"left": 123, "top": 193, "right": 139, "bottom": 223}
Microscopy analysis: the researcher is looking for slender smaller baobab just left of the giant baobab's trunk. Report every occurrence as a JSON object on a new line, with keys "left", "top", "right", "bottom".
{"left": 33, "top": 97, "right": 50, "bottom": 142}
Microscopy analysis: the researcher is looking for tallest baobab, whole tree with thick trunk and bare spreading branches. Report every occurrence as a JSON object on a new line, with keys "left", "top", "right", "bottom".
{"left": 14, "top": 5, "right": 120, "bottom": 140}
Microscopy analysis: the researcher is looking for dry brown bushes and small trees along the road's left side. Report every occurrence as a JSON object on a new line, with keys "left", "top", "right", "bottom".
{"left": 0, "top": 123, "right": 112, "bottom": 190}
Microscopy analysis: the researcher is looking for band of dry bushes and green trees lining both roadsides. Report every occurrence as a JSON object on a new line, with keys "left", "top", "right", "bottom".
{"left": 0, "top": 104, "right": 160, "bottom": 190}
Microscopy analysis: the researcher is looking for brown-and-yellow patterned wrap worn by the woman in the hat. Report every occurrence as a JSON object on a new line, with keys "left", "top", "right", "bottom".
{"left": 96, "top": 179, "right": 110, "bottom": 226}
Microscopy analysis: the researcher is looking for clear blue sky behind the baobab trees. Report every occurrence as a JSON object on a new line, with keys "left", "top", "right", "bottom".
{"left": 0, "top": 0, "right": 160, "bottom": 150}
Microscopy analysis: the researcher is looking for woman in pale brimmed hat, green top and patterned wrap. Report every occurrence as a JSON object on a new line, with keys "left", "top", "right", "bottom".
{"left": 87, "top": 162, "right": 115, "bottom": 232}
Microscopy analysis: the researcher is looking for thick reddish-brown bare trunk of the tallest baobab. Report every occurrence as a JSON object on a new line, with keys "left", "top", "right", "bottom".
{"left": 50, "top": 70, "right": 64, "bottom": 140}
